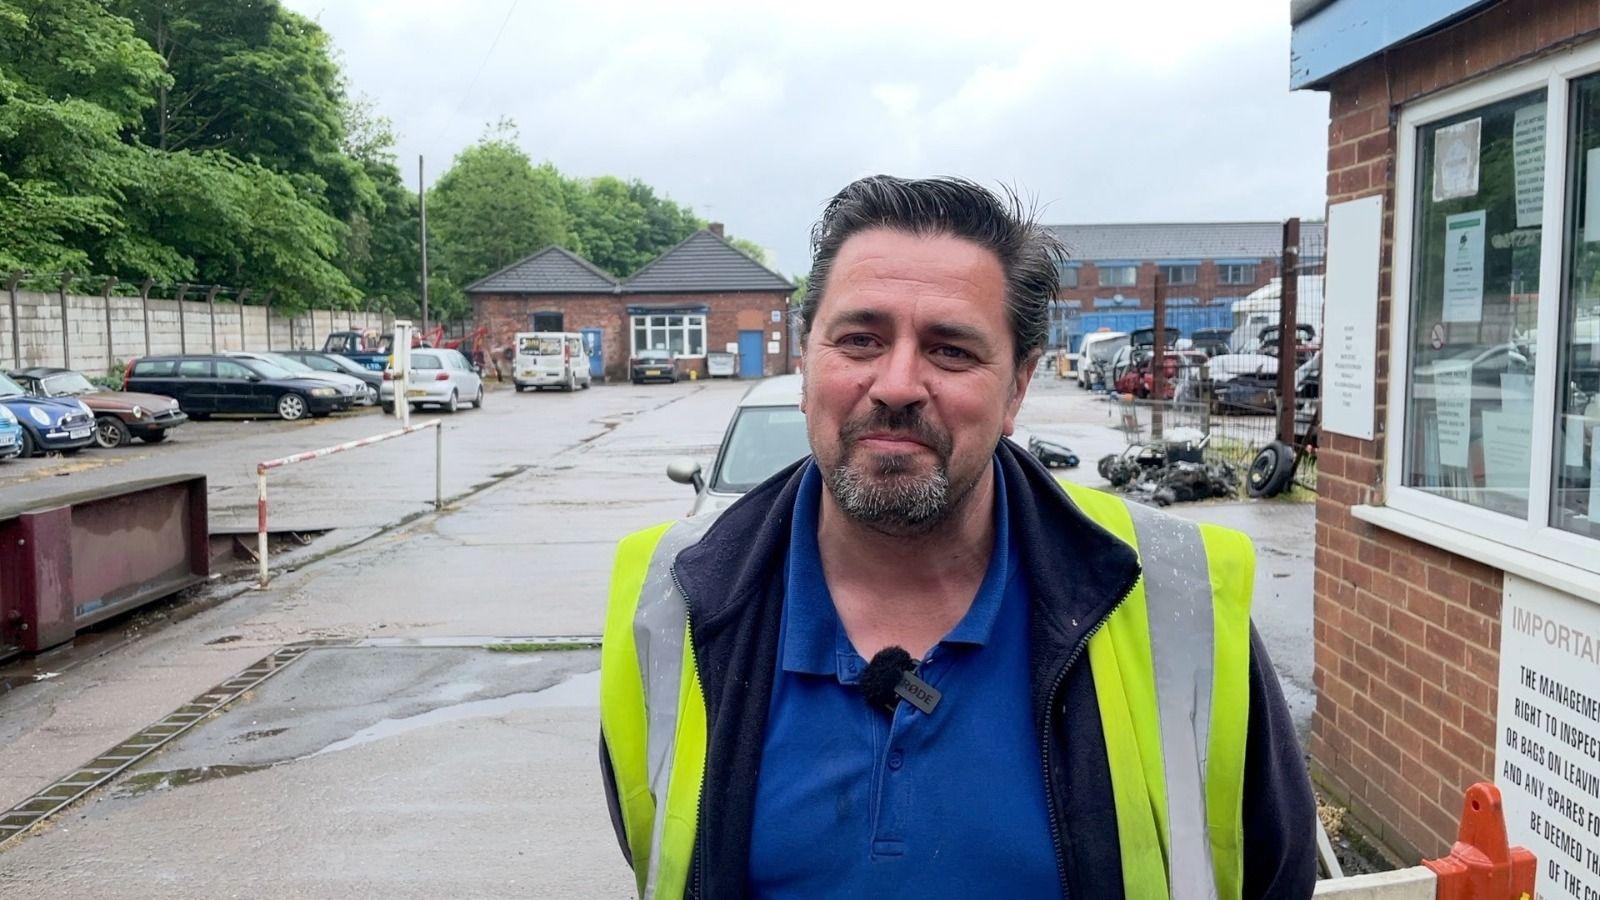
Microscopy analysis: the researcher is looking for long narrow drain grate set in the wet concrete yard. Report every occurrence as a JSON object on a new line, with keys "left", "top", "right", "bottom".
{"left": 0, "top": 644, "right": 312, "bottom": 850}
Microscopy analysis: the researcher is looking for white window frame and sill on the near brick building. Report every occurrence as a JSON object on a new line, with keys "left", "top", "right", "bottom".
{"left": 1382, "top": 42, "right": 1600, "bottom": 581}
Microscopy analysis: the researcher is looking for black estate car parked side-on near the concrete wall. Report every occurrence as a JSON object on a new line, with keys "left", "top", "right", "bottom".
{"left": 122, "top": 354, "right": 350, "bottom": 421}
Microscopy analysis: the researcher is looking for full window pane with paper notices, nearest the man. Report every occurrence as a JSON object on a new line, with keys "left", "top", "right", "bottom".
{"left": 1403, "top": 91, "right": 1544, "bottom": 517}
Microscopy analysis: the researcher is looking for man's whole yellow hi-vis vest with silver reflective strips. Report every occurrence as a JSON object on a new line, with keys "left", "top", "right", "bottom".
{"left": 600, "top": 482, "right": 1254, "bottom": 900}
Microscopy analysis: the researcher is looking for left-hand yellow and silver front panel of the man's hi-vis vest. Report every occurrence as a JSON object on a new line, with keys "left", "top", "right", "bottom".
{"left": 600, "top": 516, "right": 714, "bottom": 898}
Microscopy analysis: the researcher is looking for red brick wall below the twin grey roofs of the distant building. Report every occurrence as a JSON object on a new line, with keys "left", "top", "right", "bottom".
{"left": 472, "top": 291, "right": 790, "bottom": 381}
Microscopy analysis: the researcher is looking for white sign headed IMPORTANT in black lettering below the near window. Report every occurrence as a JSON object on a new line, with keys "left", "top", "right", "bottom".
{"left": 1494, "top": 572, "right": 1600, "bottom": 900}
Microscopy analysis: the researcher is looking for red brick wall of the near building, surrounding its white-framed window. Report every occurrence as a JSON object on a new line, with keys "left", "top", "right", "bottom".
{"left": 1309, "top": 0, "right": 1600, "bottom": 860}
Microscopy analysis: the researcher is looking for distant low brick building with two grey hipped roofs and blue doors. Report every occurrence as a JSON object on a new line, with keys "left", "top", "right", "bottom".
{"left": 467, "top": 224, "right": 794, "bottom": 381}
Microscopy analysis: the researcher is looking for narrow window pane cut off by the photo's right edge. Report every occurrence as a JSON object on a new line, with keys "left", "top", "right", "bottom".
{"left": 1550, "top": 75, "right": 1600, "bottom": 538}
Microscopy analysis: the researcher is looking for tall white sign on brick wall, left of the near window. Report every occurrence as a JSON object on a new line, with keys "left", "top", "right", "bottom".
{"left": 1322, "top": 197, "right": 1384, "bottom": 440}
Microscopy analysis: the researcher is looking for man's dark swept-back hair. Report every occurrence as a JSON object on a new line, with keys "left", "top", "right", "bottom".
{"left": 800, "top": 175, "right": 1067, "bottom": 364}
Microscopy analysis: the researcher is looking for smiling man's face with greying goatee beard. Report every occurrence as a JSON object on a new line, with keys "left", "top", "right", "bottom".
{"left": 802, "top": 229, "right": 1034, "bottom": 535}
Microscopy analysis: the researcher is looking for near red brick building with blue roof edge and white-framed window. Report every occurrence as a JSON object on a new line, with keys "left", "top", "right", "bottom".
{"left": 1291, "top": 0, "right": 1600, "bottom": 877}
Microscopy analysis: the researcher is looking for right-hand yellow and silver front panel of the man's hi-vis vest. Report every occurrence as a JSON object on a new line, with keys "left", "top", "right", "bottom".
{"left": 1067, "top": 485, "right": 1254, "bottom": 900}
